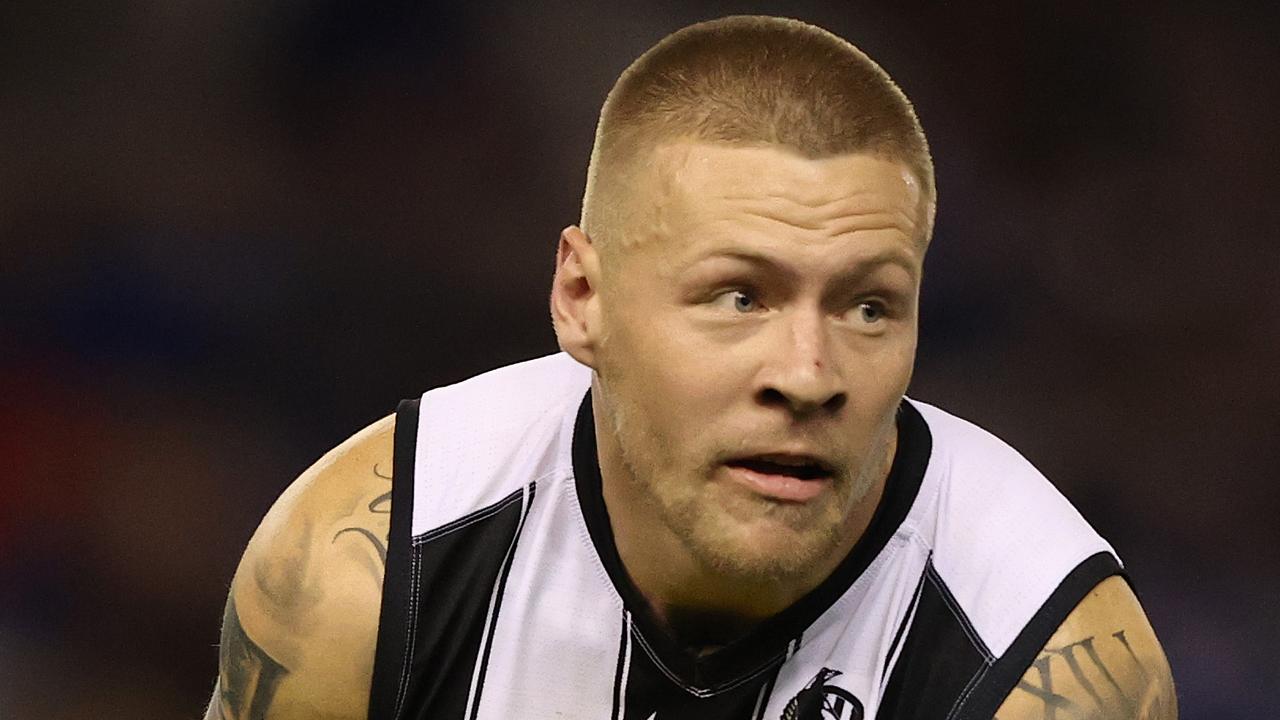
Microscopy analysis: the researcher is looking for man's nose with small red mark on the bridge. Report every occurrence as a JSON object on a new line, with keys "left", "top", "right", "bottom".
{"left": 756, "top": 311, "right": 849, "bottom": 416}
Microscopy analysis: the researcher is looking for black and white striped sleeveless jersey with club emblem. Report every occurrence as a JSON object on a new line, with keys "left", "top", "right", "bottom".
{"left": 369, "top": 355, "right": 1123, "bottom": 720}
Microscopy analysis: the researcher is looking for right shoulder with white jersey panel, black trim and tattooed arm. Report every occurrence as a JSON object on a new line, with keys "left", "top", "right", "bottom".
{"left": 896, "top": 401, "right": 1176, "bottom": 720}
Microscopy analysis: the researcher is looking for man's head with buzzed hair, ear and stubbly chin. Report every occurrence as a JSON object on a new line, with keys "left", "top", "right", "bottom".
{"left": 552, "top": 18, "right": 934, "bottom": 589}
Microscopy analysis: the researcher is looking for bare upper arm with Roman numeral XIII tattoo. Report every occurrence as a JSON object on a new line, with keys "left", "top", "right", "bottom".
{"left": 996, "top": 577, "right": 1178, "bottom": 720}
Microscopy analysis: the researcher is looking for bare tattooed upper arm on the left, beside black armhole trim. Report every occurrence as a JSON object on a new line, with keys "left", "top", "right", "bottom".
{"left": 205, "top": 416, "right": 394, "bottom": 720}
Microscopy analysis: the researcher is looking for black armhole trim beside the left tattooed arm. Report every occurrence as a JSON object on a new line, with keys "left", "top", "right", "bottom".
{"left": 369, "top": 400, "right": 419, "bottom": 720}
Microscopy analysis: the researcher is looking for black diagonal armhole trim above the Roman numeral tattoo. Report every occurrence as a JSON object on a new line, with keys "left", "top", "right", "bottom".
{"left": 954, "top": 552, "right": 1129, "bottom": 720}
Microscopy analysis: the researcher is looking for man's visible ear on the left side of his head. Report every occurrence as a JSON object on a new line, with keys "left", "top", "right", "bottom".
{"left": 550, "top": 225, "right": 603, "bottom": 369}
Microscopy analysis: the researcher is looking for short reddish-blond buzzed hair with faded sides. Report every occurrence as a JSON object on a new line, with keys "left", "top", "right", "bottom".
{"left": 581, "top": 15, "right": 936, "bottom": 250}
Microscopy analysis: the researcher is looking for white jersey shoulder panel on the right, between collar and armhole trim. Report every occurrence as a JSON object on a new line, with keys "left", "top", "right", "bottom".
{"left": 910, "top": 401, "right": 1123, "bottom": 673}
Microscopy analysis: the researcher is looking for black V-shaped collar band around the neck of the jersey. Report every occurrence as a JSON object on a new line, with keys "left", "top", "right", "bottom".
{"left": 573, "top": 391, "right": 933, "bottom": 689}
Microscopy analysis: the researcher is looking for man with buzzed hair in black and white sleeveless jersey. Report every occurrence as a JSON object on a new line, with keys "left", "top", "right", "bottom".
{"left": 207, "top": 17, "right": 1176, "bottom": 720}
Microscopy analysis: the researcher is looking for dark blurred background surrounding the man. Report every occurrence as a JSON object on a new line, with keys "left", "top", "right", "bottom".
{"left": 0, "top": 0, "right": 1280, "bottom": 720}
